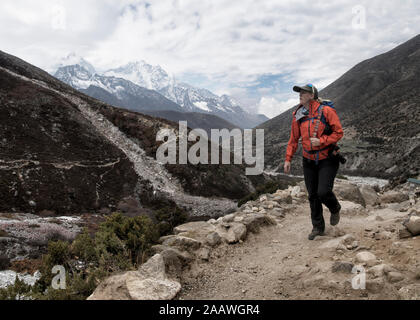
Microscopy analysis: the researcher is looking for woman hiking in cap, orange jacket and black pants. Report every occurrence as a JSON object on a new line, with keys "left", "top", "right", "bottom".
{"left": 284, "top": 84, "right": 344, "bottom": 240}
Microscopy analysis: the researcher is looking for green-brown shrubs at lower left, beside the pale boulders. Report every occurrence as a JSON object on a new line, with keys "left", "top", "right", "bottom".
{"left": 0, "top": 213, "right": 159, "bottom": 300}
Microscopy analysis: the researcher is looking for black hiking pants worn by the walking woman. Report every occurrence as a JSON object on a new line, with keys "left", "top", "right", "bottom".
{"left": 303, "top": 158, "right": 340, "bottom": 231}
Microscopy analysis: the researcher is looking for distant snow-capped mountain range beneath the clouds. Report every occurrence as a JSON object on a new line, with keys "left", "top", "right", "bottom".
{"left": 55, "top": 55, "right": 268, "bottom": 128}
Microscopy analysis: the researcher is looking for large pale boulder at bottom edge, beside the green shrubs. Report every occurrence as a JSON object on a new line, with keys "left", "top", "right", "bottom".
{"left": 88, "top": 254, "right": 181, "bottom": 300}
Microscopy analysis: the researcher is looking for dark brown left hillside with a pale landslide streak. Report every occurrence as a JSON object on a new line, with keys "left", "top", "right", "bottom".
{"left": 0, "top": 52, "right": 278, "bottom": 220}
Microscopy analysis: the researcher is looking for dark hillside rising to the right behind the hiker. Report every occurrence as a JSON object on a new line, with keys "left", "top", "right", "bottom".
{"left": 258, "top": 35, "right": 420, "bottom": 178}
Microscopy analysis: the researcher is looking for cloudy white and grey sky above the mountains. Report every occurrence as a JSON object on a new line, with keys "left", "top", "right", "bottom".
{"left": 0, "top": 0, "right": 420, "bottom": 117}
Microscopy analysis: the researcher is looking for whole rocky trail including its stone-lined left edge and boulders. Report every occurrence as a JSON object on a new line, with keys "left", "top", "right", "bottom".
{"left": 89, "top": 179, "right": 420, "bottom": 300}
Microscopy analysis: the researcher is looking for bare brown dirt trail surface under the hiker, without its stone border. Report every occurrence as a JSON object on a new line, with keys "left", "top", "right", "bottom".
{"left": 177, "top": 194, "right": 420, "bottom": 300}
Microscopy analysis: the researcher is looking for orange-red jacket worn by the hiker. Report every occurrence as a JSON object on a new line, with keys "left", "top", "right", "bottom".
{"left": 286, "top": 100, "right": 344, "bottom": 161}
